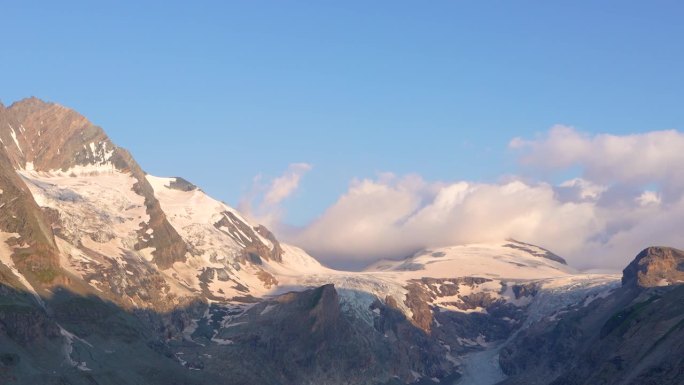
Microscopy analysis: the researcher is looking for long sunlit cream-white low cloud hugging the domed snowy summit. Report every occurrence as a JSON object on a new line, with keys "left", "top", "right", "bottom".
{"left": 288, "top": 177, "right": 599, "bottom": 265}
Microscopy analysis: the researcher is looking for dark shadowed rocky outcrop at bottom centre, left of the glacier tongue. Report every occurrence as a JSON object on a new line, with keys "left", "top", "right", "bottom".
{"left": 183, "top": 285, "right": 454, "bottom": 385}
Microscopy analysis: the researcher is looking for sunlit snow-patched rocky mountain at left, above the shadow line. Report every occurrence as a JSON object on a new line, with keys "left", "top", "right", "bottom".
{"left": 0, "top": 99, "right": 320, "bottom": 311}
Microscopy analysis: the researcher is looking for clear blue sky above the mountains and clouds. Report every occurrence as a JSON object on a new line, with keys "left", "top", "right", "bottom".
{"left": 0, "top": 1, "right": 684, "bottom": 228}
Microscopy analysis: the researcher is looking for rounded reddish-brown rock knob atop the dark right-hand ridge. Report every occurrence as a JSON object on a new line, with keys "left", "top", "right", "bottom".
{"left": 622, "top": 246, "right": 684, "bottom": 287}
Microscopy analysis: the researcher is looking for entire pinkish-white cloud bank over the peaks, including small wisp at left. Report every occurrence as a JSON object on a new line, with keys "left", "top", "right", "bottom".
{"left": 248, "top": 126, "right": 684, "bottom": 269}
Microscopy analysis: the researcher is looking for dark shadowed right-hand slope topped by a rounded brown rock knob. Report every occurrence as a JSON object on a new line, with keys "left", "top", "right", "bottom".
{"left": 500, "top": 247, "right": 684, "bottom": 385}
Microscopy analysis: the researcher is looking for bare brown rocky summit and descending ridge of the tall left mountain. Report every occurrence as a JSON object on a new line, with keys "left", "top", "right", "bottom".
{"left": 0, "top": 97, "right": 187, "bottom": 268}
